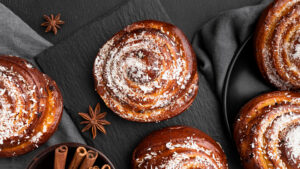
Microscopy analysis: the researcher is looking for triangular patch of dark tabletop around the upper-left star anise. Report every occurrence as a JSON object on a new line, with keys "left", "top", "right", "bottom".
{"left": 0, "top": 0, "right": 128, "bottom": 44}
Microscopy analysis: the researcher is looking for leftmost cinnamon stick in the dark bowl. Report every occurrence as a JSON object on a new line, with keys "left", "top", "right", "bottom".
{"left": 54, "top": 145, "right": 68, "bottom": 169}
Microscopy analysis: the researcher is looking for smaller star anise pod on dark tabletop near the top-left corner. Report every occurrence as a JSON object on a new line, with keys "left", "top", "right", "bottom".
{"left": 41, "top": 13, "right": 65, "bottom": 35}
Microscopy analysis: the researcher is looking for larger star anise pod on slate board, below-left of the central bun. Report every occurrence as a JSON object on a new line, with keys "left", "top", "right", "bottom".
{"left": 78, "top": 103, "right": 110, "bottom": 139}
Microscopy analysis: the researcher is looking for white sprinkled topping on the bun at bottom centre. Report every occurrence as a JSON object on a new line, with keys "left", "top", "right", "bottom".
{"left": 136, "top": 137, "right": 227, "bottom": 169}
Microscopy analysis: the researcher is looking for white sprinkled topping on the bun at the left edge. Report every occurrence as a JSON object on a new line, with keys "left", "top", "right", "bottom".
{"left": 0, "top": 66, "right": 37, "bottom": 144}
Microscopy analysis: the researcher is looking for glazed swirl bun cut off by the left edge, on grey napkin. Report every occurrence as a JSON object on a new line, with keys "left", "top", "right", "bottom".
{"left": 0, "top": 56, "right": 63, "bottom": 157}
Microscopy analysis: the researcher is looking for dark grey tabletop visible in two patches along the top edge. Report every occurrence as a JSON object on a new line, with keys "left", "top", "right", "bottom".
{"left": 0, "top": 0, "right": 261, "bottom": 44}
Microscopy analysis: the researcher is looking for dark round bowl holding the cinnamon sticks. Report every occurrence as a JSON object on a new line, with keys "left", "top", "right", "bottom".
{"left": 27, "top": 143, "right": 115, "bottom": 169}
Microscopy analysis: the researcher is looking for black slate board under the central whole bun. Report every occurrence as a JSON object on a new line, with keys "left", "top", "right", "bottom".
{"left": 36, "top": 0, "right": 240, "bottom": 168}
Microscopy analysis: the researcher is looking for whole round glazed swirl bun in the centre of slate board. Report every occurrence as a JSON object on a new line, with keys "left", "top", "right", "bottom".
{"left": 93, "top": 21, "right": 198, "bottom": 122}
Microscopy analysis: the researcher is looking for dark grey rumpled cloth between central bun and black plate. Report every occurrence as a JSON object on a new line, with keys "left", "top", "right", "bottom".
{"left": 192, "top": 0, "right": 272, "bottom": 99}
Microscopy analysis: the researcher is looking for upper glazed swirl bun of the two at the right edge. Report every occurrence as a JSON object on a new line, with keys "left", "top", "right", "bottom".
{"left": 255, "top": 0, "right": 300, "bottom": 90}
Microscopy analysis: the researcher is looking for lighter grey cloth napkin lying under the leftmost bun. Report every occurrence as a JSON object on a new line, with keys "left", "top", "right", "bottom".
{"left": 0, "top": 3, "right": 85, "bottom": 169}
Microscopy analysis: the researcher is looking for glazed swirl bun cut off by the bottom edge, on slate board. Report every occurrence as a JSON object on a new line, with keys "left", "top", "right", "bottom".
{"left": 132, "top": 126, "right": 228, "bottom": 169}
